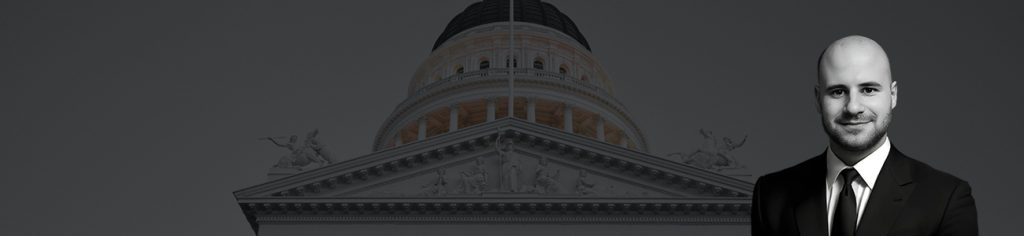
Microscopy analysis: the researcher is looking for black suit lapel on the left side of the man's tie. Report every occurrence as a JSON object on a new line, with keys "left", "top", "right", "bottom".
{"left": 794, "top": 154, "right": 828, "bottom": 236}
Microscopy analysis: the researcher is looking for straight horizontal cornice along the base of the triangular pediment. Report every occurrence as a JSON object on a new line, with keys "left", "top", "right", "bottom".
{"left": 239, "top": 198, "right": 751, "bottom": 225}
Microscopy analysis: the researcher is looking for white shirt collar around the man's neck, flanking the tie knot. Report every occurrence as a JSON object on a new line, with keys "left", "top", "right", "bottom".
{"left": 825, "top": 135, "right": 891, "bottom": 189}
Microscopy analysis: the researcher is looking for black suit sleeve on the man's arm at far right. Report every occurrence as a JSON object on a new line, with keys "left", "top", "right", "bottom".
{"left": 938, "top": 182, "right": 978, "bottom": 236}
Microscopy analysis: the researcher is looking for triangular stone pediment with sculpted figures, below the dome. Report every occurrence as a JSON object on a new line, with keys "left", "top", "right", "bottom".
{"left": 236, "top": 119, "right": 753, "bottom": 199}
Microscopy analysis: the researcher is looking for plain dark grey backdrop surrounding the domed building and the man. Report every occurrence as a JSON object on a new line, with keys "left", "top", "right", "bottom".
{"left": 0, "top": 0, "right": 1024, "bottom": 235}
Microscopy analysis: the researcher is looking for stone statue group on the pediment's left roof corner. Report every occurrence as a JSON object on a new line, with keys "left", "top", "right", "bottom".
{"left": 260, "top": 129, "right": 331, "bottom": 170}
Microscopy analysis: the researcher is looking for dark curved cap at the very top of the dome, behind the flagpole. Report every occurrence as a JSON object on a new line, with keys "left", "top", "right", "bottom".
{"left": 431, "top": 0, "right": 590, "bottom": 50}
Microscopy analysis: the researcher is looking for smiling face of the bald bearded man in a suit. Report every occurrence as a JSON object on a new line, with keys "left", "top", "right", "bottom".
{"left": 815, "top": 43, "right": 897, "bottom": 152}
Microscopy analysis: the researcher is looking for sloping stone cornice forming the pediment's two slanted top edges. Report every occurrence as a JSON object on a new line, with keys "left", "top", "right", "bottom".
{"left": 234, "top": 118, "right": 753, "bottom": 199}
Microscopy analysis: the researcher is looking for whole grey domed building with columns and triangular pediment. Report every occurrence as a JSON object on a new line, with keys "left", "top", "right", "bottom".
{"left": 234, "top": 0, "right": 753, "bottom": 235}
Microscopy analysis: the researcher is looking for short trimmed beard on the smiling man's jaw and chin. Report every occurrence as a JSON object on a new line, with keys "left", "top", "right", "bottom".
{"left": 821, "top": 113, "right": 893, "bottom": 152}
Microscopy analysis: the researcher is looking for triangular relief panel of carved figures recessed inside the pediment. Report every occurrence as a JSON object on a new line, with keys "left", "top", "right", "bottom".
{"left": 348, "top": 140, "right": 678, "bottom": 197}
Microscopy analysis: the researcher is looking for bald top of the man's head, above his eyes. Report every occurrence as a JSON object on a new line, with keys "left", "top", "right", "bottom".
{"left": 818, "top": 35, "right": 892, "bottom": 84}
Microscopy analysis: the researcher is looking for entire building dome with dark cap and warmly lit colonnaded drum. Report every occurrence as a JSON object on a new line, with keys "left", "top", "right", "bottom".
{"left": 373, "top": 0, "right": 647, "bottom": 152}
